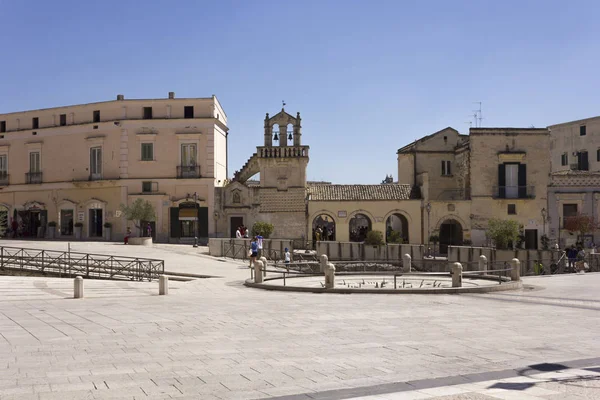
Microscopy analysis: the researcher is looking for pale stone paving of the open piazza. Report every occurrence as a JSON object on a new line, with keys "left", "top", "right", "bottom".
{"left": 0, "top": 241, "right": 600, "bottom": 400}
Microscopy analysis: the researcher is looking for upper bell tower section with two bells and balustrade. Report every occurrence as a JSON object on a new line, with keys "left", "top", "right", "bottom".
{"left": 256, "top": 103, "right": 309, "bottom": 191}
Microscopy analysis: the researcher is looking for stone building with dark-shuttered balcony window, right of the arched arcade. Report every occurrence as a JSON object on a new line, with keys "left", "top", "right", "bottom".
{"left": 398, "top": 128, "right": 550, "bottom": 253}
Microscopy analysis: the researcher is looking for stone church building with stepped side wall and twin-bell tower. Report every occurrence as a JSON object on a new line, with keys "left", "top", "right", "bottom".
{"left": 215, "top": 108, "right": 309, "bottom": 239}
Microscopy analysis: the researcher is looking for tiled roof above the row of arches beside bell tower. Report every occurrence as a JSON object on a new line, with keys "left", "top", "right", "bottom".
{"left": 308, "top": 183, "right": 415, "bottom": 201}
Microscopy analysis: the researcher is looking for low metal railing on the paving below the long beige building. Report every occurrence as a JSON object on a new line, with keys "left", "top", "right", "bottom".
{"left": 0, "top": 246, "right": 165, "bottom": 281}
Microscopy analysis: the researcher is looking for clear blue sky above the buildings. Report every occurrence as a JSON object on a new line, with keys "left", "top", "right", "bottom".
{"left": 0, "top": 0, "right": 600, "bottom": 183}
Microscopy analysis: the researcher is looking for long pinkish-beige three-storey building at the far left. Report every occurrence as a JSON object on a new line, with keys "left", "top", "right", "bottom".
{"left": 0, "top": 93, "right": 228, "bottom": 242}
